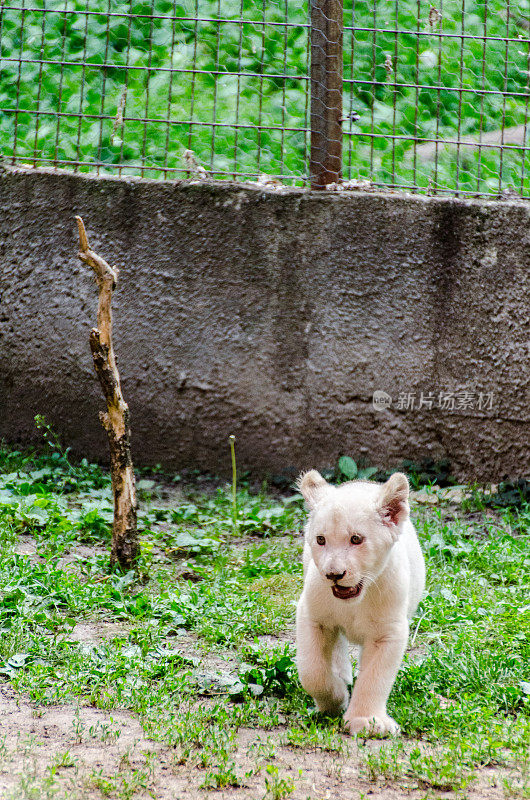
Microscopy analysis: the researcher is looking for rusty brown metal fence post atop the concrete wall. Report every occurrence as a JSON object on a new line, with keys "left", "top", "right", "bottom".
{"left": 309, "top": 0, "right": 343, "bottom": 189}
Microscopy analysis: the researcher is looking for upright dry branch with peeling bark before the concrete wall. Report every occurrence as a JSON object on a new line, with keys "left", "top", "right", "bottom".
{"left": 76, "top": 217, "right": 139, "bottom": 569}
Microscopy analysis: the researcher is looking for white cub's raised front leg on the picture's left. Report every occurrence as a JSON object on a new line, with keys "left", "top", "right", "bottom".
{"left": 296, "top": 614, "right": 349, "bottom": 714}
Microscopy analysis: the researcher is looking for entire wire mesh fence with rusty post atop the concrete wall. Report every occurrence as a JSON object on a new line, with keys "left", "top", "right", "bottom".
{"left": 0, "top": 0, "right": 530, "bottom": 197}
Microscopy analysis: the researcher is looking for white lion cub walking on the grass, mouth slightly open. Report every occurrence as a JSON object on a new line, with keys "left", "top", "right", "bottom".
{"left": 296, "top": 470, "right": 425, "bottom": 734}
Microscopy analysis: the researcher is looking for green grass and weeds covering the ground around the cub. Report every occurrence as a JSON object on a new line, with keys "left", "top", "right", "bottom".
{"left": 0, "top": 443, "right": 530, "bottom": 798}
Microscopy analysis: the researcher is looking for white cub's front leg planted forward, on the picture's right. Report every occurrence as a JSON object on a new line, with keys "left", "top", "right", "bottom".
{"left": 344, "top": 622, "right": 408, "bottom": 735}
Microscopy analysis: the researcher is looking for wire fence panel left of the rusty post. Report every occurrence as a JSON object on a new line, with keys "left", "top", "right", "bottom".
{"left": 0, "top": 0, "right": 309, "bottom": 178}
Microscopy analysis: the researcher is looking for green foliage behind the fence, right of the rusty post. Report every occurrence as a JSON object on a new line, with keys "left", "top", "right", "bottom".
{"left": 345, "top": 0, "right": 529, "bottom": 193}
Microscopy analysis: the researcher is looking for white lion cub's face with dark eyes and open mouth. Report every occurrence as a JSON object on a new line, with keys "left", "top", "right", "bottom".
{"left": 299, "top": 470, "right": 409, "bottom": 600}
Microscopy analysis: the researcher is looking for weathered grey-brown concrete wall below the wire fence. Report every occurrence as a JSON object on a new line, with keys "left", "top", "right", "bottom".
{"left": 0, "top": 170, "right": 530, "bottom": 480}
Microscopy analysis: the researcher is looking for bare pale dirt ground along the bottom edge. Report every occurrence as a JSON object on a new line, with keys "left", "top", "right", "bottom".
{"left": 0, "top": 648, "right": 505, "bottom": 800}
